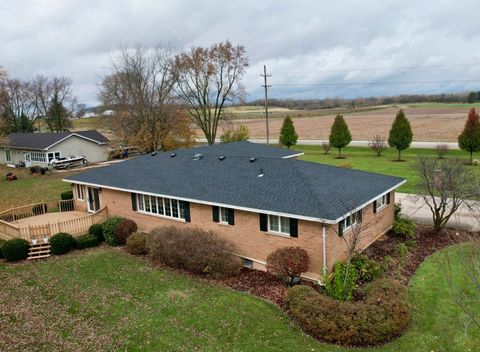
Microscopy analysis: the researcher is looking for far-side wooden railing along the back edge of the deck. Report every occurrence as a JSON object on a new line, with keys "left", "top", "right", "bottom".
{"left": 0, "top": 199, "right": 75, "bottom": 222}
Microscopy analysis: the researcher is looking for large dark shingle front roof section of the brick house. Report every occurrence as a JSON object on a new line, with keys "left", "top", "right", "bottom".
{"left": 66, "top": 148, "right": 404, "bottom": 222}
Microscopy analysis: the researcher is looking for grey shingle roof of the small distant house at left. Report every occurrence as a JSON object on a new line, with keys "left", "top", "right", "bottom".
{"left": 7, "top": 130, "right": 108, "bottom": 150}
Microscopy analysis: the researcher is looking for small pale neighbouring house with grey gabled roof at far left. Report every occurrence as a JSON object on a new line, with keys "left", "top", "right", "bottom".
{"left": 0, "top": 130, "right": 108, "bottom": 167}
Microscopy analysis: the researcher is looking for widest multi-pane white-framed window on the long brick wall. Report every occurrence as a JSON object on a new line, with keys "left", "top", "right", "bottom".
{"left": 136, "top": 194, "right": 185, "bottom": 219}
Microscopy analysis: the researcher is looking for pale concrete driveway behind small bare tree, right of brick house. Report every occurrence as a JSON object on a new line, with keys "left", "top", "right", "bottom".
{"left": 395, "top": 193, "right": 480, "bottom": 231}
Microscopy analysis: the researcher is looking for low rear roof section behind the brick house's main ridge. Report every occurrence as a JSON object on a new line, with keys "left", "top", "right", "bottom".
{"left": 186, "top": 142, "right": 303, "bottom": 158}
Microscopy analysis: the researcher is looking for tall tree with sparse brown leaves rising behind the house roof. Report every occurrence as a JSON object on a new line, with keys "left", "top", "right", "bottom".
{"left": 175, "top": 41, "right": 248, "bottom": 144}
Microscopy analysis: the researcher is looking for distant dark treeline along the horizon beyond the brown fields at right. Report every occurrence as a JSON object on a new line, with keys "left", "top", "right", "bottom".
{"left": 246, "top": 91, "right": 480, "bottom": 110}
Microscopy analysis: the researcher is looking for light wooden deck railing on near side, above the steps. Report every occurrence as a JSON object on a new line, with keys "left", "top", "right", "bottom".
{"left": 0, "top": 208, "right": 107, "bottom": 241}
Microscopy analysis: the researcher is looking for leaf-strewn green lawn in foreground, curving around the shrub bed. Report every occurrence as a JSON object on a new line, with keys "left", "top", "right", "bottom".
{"left": 0, "top": 243, "right": 480, "bottom": 352}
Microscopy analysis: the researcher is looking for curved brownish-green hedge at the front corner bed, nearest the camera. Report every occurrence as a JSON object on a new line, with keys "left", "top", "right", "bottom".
{"left": 285, "top": 279, "right": 411, "bottom": 346}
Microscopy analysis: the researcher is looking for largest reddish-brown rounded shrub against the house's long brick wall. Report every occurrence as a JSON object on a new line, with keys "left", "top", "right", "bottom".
{"left": 147, "top": 226, "right": 242, "bottom": 277}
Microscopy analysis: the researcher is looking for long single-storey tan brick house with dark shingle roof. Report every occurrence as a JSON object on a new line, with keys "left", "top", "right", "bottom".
{"left": 65, "top": 142, "right": 405, "bottom": 279}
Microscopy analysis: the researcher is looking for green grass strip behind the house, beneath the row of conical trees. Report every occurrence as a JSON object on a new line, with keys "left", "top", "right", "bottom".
{"left": 293, "top": 145, "right": 480, "bottom": 193}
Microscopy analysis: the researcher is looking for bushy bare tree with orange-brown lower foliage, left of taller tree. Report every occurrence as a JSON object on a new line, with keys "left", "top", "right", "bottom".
{"left": 100, "top": 46, "right": 192, "bottom": 152}
